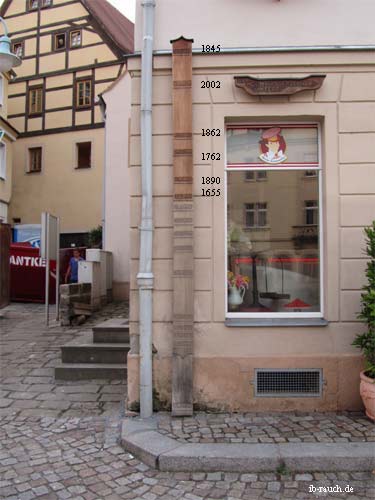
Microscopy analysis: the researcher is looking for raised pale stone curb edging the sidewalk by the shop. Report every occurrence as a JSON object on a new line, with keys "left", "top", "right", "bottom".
{"left": 121, "top": 417, "right": 375, "bottom": 472}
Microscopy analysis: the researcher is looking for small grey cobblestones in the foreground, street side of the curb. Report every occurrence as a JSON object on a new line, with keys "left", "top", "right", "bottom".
{"left": 0, "top": 415, "right": 375, "bottom": 500}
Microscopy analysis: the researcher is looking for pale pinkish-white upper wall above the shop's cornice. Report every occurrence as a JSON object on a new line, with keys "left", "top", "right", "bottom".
{"left": 135, "top": 0, "right": 375, "bottom": 50}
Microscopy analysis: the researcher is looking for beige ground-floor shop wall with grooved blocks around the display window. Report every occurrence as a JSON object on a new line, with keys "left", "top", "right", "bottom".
{"left": 128, "top": 51, "right": 375, "bottom": 411}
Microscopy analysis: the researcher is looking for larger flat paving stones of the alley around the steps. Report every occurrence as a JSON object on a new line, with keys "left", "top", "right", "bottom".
{"left": 0, "top": 303, "right": 128, "bottom": 417}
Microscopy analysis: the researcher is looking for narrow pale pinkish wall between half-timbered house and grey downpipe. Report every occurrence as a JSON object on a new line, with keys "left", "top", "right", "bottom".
{"left": 103, "top": 72, "right": 131, "bottom": 300}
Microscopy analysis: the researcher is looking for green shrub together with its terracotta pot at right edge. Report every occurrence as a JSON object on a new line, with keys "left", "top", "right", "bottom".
{"left": 352, "top": 221, "right": 375, "bottom": 420}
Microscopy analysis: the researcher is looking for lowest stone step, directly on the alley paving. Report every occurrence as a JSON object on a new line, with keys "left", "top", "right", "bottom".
{"left": 55, "top": 363, "right": 127, "bottom": 381}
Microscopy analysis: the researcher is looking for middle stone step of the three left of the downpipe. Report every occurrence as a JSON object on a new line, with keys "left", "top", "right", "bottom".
{"left": 61, "top": 332, "right": 130, "bottom": 364}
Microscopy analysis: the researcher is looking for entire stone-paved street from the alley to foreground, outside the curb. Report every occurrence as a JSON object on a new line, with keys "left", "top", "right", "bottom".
{"left": 0, "top": 304, "right": 375, "bottom": 500}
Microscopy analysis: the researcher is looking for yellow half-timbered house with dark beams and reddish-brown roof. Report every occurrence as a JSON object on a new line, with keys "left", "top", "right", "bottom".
{"left": 0, "top": 0, "right": 134, "bottom": 245}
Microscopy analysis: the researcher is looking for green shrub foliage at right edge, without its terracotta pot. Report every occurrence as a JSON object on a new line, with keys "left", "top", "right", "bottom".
{"left": 352, "top": 221, "right": 375, "bottom": 381}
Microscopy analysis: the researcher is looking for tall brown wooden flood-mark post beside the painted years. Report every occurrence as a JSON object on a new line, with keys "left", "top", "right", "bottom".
{"left": 171, "top": 37, "right": 194, "bottom": 416}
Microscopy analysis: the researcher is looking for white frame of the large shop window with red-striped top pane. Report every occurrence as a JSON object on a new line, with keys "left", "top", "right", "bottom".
{"left": 224, "top": 121, "right": 325, "bottom": 320}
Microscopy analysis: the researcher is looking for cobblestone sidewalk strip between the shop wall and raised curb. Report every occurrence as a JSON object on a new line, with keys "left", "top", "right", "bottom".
{"left": 158, "top": 412, "right": 375, "bottom": 446}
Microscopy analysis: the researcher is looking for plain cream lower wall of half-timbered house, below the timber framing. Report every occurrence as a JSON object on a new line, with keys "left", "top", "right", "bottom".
{"left": 11, "top": 129, "right": 104, "bottom": 233}
